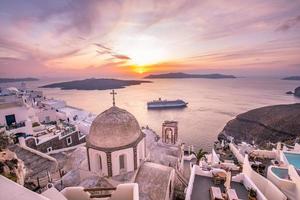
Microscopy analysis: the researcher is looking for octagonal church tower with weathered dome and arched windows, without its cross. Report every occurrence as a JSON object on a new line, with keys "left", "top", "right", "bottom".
{"left": 86, "top": 106, "right": 146, "bottom": 177}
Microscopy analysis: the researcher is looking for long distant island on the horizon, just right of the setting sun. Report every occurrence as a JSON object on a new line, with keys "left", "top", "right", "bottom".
{"left": 144, "top": 72, "right": 236, "bottom": 79}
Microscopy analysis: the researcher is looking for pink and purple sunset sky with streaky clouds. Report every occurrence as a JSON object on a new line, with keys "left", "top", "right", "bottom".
{"left": 0, "top": 0, "right": 300, "bottom": 77}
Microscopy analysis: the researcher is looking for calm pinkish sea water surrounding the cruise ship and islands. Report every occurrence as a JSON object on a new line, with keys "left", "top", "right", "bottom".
{"left": 1, "top": 78, "right": 300, "bottom": 151}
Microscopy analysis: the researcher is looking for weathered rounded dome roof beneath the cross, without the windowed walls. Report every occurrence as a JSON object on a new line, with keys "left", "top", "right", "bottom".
{"left": 87, "top": 106, "right": 142, "bottom": 149}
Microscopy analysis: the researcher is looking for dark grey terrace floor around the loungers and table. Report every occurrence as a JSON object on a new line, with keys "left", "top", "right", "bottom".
{"left": 191, "top": 175, "right": 248, "bottom": 200}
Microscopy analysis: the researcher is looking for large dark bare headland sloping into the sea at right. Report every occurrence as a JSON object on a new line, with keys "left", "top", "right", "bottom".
{"left": 218, "top": 103, "right": 300, "bottom": 148}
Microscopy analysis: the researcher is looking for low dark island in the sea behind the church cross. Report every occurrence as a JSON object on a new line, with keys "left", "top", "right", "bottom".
{"left": 41, "top": 78, "right": 151, "bottom": 90}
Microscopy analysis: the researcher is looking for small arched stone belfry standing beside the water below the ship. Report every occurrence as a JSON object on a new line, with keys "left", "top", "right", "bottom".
{"left": 162, "top": 121, "right": 178, "bottom": 144}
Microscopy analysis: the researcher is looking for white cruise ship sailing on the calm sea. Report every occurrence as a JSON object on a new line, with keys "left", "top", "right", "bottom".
{"left": 147, "top": 98, "right": 188, "bottom": 109}
